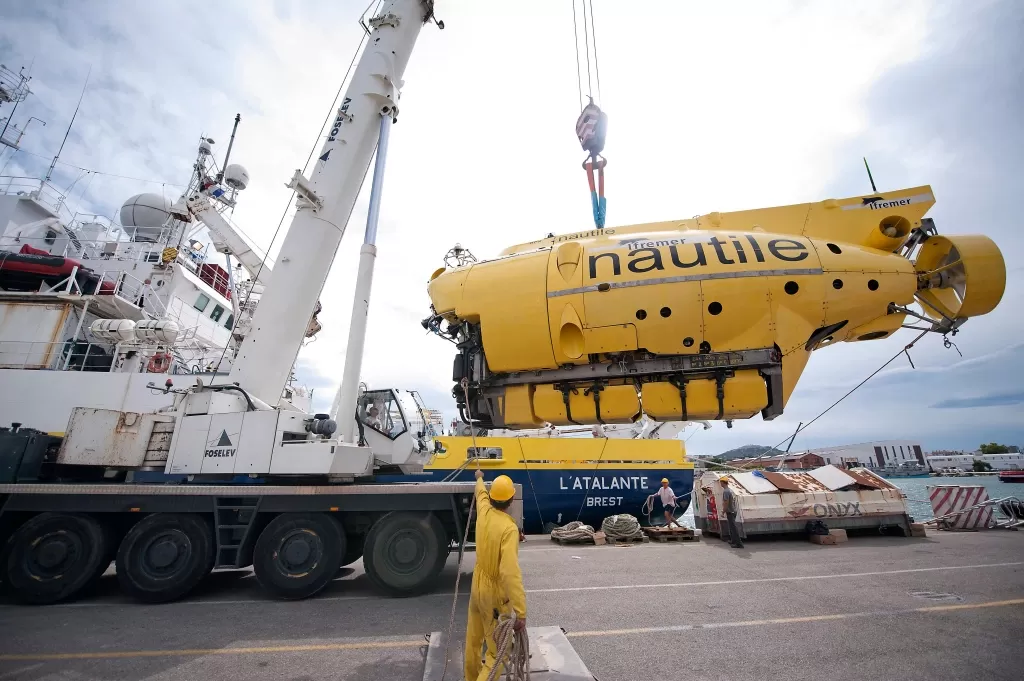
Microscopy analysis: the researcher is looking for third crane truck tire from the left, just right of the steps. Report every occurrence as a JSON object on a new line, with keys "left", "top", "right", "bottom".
{"left": 253, "top": 513, "right": 345, "bottom": 600}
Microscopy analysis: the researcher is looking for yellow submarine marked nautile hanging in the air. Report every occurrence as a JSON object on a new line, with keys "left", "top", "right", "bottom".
{"left": 423, "top": 186, "right": 1006, "bottom": 429}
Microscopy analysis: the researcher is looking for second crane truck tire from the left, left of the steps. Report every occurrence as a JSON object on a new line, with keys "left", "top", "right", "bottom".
{"left": 117, "top": 513, "right": 215, "bottom": 603}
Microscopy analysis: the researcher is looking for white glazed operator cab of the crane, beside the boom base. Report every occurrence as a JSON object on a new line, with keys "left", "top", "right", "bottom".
{"left": 355, "top": 389, "right": 433, "bottom": 473}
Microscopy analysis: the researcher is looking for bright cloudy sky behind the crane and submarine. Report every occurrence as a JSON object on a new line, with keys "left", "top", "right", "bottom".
{"left": 0, "top": 0, "right": 1024, "bottom": 454}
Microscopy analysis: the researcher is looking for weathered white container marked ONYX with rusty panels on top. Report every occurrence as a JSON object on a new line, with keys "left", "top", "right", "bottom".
{"left": 693, "top": 465, "right": 912, "bottom": 537}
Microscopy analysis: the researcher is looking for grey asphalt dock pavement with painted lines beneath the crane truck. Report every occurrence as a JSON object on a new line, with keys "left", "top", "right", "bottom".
{"left": 0, "top": 531, "right": 1024, "bottom": 681}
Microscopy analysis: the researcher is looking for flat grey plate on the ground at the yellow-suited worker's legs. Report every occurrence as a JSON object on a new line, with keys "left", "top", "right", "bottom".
{"left": 423, "top": 627, "right": 595, "bottom": 681}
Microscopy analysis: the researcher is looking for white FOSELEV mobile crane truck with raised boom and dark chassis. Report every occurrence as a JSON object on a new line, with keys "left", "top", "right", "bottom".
{"left": 0, "top": 0, "right": 493, "bottom": 603}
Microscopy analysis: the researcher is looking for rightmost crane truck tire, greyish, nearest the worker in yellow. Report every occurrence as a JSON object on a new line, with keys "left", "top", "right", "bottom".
{"left": 362, "top": 511, "right": 449, "bottom": 597}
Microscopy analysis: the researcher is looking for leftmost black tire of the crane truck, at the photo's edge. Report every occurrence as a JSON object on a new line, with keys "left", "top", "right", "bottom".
{"left": 0, "top": 513, "right": 110, "bottom": 605}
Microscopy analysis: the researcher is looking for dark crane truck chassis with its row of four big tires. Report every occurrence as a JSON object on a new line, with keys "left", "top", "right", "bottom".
{"left": 0, "top": 482, "right": 483, "bottom": 604}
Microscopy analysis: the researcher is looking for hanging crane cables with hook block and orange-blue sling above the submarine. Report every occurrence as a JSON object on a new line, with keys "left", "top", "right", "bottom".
{"left": 572, "top": 0, "right": 608, "bottom": 229}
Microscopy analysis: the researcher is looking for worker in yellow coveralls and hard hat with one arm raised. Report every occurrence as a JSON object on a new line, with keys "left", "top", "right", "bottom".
{"left": 465, "top": 470, "right": 526, "bottom": 681}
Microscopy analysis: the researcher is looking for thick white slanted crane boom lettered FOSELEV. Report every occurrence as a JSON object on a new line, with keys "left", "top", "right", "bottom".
{"left": 228, "top": 0, "right": 433, "bottom": 405}
